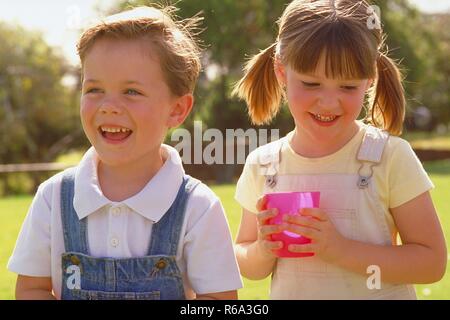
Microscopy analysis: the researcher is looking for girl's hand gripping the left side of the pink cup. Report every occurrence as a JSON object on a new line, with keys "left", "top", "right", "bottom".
{"left": 256, "top": 196, "right": 283, "bottom": 258}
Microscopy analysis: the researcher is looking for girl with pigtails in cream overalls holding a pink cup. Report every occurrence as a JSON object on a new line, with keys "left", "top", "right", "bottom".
{"left": 234, "top": 0, "right": 447, "bottom": 299}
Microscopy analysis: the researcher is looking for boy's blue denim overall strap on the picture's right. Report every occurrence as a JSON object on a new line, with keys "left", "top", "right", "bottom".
{"left": 147, "top": 175, "right": 200, "bottom": 256}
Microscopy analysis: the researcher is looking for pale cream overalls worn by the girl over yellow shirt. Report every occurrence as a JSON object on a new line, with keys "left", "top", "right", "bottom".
{"left": 259, "top": 126, "right": 416, "bottom": 299}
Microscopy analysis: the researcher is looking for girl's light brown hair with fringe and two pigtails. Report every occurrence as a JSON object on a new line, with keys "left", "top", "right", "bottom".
{"left": 233, "top": 0, "right": 405, "bottom": 135}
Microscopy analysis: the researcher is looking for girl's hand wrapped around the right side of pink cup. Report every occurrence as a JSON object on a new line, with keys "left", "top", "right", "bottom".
{"left": 283, "top": 208, "right": 346, "bottom": 263}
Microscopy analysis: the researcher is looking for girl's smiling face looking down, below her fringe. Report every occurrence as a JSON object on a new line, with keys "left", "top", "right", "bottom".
{"left": 276, "top": 55, "right": 372, "bottom": 152}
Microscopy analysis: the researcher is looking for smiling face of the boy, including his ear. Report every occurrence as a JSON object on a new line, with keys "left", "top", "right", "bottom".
{"left": 80, "top": 39, "right": 192, "bottom": 166}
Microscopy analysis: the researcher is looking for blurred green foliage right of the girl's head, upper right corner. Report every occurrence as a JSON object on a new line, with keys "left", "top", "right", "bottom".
{"left": 374, "top": 0, "right": 450, "bottom": 127}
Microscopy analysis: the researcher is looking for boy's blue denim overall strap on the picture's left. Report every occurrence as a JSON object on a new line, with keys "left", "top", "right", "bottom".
{"left": 61, "top": 168, "right": 88, "bottom": 254}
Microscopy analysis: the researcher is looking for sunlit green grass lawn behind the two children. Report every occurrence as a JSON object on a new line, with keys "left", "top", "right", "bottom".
{"left": 0, "top": 161, "right": 450, "bottom": 299}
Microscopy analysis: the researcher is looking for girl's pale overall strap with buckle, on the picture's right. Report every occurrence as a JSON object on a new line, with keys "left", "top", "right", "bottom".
{"left": 357, "top": 126, "right": 389, "bottom": 189}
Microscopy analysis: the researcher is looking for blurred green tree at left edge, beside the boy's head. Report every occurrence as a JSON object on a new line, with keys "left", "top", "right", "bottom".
{"left": 0, "top": 23, "right": 81, "bottom": 192}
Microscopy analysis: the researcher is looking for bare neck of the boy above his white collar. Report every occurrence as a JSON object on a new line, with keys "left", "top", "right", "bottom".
{"left": 97, "top": 150, "right": 167, "bottom": 202}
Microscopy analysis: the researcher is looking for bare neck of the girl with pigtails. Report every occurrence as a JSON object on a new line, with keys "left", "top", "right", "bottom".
{"left": 289, "top": 122, "right": 360, "bottom": 158}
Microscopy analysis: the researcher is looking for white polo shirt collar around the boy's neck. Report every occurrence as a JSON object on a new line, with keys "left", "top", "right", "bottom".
{"left": 73, "top": 144, "right": 184, "bottom": 222}
